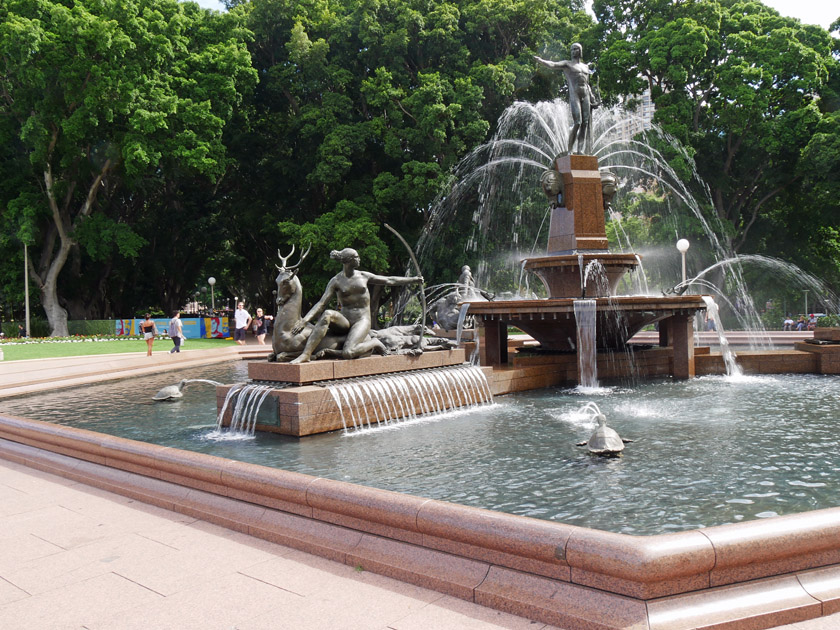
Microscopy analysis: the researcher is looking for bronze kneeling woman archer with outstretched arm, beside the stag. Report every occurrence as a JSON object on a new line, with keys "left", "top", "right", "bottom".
{"left": 290, "top": 247, "right": 423, "bottom": 363}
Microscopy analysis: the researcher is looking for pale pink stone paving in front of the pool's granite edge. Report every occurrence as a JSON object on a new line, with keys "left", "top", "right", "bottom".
{"left": 0, "top": 460, "right": 564, "bottom": 630}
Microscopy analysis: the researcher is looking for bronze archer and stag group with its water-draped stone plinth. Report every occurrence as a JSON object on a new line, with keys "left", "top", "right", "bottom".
{"left": 216, "top": 248, "right": 493, "bottom": 437}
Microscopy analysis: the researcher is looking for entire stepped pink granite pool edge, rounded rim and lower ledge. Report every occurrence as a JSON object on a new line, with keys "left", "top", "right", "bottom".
{"left": 0, "top": 416, "right": 840, "bottom": 630}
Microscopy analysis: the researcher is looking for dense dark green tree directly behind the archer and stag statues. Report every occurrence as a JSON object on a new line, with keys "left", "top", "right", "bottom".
{"left": 221, "top": 0, "right": 586, "bottom": 310}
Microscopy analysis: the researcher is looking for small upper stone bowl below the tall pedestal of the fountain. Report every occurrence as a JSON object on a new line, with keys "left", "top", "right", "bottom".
{"left": 525, "top": 251, "right": 639, "bottom": 298}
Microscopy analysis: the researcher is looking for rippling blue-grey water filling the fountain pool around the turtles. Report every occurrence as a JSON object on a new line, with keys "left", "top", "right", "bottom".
{"left": 0, "top": 362, "right": 840, "bottom": 535}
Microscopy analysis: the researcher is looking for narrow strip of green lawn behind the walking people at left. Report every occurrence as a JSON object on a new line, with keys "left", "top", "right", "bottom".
{"left": 0, "top": 339, "right": 234, "bottom": 361}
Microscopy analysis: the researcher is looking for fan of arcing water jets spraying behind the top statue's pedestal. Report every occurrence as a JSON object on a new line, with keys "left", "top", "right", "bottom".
{"left": 417, "top": 99, "right": 816, "bottom": 346}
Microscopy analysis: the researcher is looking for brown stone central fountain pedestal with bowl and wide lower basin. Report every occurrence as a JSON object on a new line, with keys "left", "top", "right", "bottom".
{"left": 469, "top": 155, "right": 706, "bottom": 381}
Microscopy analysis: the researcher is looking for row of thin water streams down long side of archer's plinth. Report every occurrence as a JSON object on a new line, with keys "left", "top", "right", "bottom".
{"left": 325, "top": 365, "right": 493, "bottom": 430}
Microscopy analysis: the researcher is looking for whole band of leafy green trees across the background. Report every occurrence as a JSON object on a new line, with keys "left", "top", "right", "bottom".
{"left": 0, "top": 0, "right": 840, "bottom": 334}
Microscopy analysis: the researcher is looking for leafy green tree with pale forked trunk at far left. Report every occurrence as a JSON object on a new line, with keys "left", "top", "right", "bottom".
{"left": 0, "top": 0, "right": 253, "bottom": 335}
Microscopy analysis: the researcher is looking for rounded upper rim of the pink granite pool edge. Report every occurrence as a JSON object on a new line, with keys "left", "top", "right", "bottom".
{"left": 0, "top": 415, "right": 840, "bottom": 592}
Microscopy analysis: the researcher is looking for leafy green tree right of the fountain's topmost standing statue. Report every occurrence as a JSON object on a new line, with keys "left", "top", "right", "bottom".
{"left": 594, "top": 0, "right": 834, "bottom": 262}
